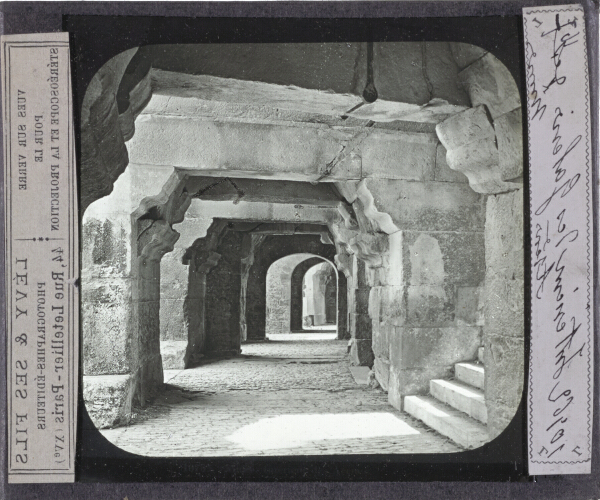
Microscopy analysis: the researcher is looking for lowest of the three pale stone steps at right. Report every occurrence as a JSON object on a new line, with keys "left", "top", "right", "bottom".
{"left": 404, "top": 396, "right": 489, "bottom": 449}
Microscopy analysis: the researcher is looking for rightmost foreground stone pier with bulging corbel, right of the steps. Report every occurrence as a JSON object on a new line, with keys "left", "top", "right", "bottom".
{"left": 438, "top": 43, "right": 525, "bottom": 439}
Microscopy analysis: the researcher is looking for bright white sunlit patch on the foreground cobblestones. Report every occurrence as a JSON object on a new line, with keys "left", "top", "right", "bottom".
{"left": 226, "top": 412, "right": 420, "bottom": 450}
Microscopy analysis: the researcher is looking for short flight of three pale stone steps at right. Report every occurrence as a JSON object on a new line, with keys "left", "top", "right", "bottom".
{"left": 404, "top": 348, "right": 489, "bottom": 449}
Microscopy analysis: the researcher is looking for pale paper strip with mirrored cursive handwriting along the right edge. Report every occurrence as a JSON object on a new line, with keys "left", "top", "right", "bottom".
{"left": 523, "top": 5, "right": 594, "bottom": 475}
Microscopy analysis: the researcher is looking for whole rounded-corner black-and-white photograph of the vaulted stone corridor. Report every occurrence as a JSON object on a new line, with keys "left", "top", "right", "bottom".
{"left": 81, "top": 42, "right": 525, "bottom": 456}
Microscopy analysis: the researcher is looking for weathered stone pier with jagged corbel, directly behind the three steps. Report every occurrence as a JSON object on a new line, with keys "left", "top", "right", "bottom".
{"left": 334, "top": 170, "right": 485, "bottom": 400}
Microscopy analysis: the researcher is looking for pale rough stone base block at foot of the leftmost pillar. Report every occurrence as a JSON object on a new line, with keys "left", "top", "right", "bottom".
{"left": 83, "top": 375, "right": 134, "bottom": 429}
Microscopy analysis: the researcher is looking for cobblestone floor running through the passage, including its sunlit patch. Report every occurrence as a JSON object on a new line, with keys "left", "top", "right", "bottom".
{"left": 101, "top": 334, "right": 460, "bottom": 457}
